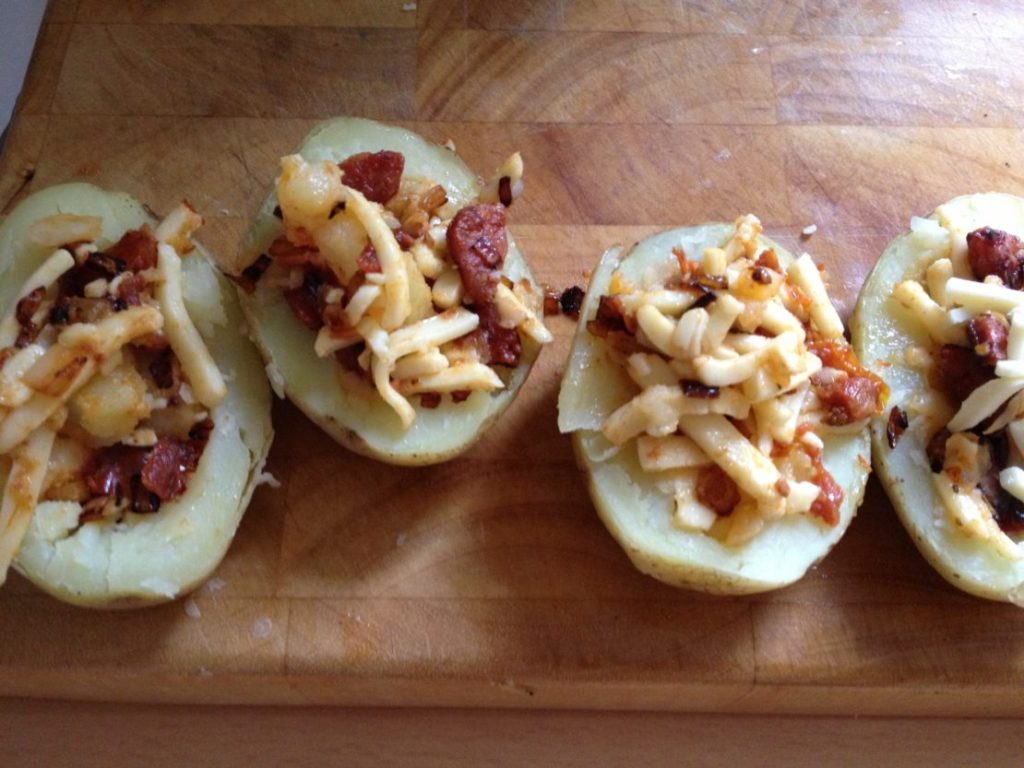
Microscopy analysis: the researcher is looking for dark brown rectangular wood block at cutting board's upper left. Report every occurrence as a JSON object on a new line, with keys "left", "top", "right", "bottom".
{"left": 53, "top": 23, "right": 415, "bottom": 120}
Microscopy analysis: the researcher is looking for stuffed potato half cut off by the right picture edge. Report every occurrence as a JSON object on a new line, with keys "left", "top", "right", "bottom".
{"left": 851, "top": 193, "right": 1024, "bottom": 602}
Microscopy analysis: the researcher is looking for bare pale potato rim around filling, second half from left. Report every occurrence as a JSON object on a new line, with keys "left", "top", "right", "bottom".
{"left": 230, "top": 118, "right": 540, "bottom": 466}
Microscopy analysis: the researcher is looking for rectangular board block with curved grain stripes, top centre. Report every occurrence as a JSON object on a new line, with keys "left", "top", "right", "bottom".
{"left": 416, "top": 30, "right": 775, "bottom": 125}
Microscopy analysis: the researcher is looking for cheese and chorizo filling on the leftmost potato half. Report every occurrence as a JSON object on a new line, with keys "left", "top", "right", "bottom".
{"left": 0, "top": 203, "right": 226, "bottom": 583}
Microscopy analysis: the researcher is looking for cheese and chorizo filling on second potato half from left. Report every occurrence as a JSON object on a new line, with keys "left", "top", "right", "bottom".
{"left": 239, "top": 151, "right": 552, "bottom": 429}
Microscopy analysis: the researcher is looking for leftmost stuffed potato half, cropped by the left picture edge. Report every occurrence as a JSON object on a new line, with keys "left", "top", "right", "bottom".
{"left": 0, "top": 183, "right": 272, "bottom": 607}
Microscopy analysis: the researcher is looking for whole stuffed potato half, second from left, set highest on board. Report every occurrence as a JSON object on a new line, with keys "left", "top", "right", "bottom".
{"left": 233, "top": 118, "right": 551, "bottom": 465}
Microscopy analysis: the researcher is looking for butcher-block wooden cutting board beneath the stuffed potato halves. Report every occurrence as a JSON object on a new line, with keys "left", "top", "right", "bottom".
{"left": 0, "top": 0, "right": 1024, "bottom": 715}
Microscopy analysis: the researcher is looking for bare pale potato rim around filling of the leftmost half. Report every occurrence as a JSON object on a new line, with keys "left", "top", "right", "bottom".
{"left": 0, "top": 183, "right": 273, "bottom": 608}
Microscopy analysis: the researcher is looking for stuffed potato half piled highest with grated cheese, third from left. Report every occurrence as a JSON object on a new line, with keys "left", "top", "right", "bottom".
{"left": 558, "top": 216, "right": 884, "bottom": 594}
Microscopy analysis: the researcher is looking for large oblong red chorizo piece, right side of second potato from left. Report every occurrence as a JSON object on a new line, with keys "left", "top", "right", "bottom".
{"left": 447, "top": 203, "right": 508, "bottom": 304}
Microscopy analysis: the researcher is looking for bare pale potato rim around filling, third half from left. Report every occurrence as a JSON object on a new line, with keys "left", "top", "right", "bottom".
{"left": 559, "top": 223, "right": 869, "bottom": 595}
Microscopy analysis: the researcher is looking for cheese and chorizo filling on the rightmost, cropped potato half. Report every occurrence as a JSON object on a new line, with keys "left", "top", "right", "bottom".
{"left": 888, "top": 219, "right": 1024, "bottom": 559}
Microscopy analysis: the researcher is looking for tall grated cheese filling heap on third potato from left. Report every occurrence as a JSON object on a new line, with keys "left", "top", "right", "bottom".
{"left": 588, "top": 215, "right": 887, "bottom": 546}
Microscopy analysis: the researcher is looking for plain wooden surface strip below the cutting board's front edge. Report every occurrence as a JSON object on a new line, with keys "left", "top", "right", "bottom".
{"left": 0, "top": 700, "right": 1022, "bottom": 768}
